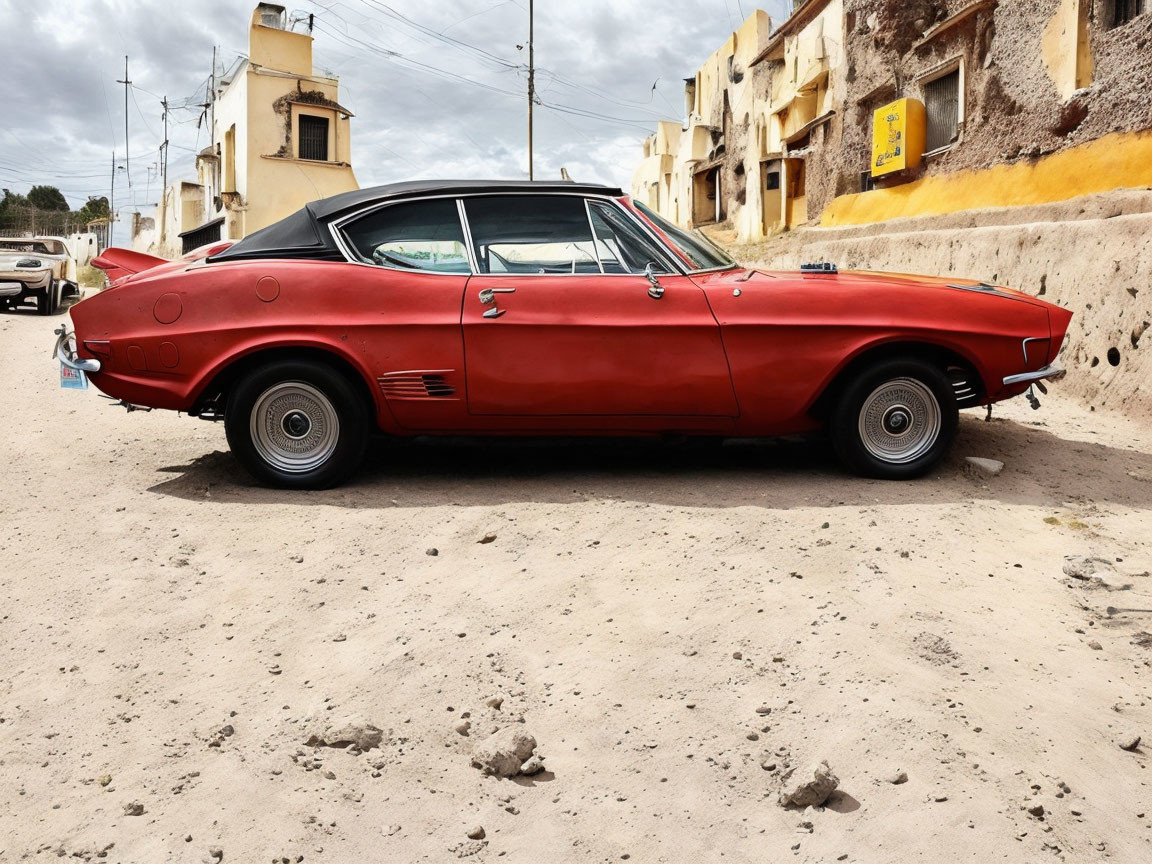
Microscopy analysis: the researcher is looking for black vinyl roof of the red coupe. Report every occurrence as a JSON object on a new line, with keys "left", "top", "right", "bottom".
{"left": 209, "top": 180, "right": 624, "bottom": 262}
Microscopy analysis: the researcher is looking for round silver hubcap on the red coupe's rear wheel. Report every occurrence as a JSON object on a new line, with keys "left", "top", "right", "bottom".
{"left": 250, "top": 381, "right": 340, "bottom": 473}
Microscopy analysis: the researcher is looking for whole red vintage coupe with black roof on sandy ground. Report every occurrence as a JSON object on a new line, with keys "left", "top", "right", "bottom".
{"left": 58, "top": 181, "right": 1071, "bottom": 488}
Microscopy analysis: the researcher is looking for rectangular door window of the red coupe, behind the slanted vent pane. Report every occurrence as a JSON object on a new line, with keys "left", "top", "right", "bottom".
{"left": 464, "top": 195, "right": 600, "bottom": 274}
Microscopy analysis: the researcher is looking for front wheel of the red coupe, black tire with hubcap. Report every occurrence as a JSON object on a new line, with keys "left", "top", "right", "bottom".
{"left": 831, "top": 357, "right": 960, "bottom": 480}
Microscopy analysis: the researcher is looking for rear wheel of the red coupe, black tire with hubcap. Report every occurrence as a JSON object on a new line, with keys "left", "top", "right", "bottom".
{"left": 225, "top": 361, "right": 371, "bottom": 490}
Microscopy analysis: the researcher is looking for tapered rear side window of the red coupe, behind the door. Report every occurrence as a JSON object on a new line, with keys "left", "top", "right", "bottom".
{"left": 343, "top": 198, "right": 471, "bottom": 273}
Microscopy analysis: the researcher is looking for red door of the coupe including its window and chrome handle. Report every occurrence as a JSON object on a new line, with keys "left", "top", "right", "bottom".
{"left": 462, "top": 195, "right": 737, "bottom": 426}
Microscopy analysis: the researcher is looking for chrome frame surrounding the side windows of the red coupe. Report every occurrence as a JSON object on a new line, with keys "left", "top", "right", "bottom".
{"left": 328, "top": 190, "right": 691, "bottom": 279}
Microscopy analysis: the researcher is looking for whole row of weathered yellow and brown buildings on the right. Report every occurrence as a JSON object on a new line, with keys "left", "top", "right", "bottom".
{"left": 632, "top": 0, "right": 1152, "bottom": 242}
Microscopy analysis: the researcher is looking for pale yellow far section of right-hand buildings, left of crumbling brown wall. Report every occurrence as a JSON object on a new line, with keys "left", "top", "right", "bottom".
{"left": 632, "top": 0, "right": 844, "bottom": 241}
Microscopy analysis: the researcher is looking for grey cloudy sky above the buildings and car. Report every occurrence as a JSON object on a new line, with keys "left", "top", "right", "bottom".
{"left": 0, "top": 0, "right": 790, "bottom": 242}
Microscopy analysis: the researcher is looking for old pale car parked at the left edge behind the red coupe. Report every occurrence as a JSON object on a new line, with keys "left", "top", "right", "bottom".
{"left": 0, "top": 237, "right": 79, "bottom": 314}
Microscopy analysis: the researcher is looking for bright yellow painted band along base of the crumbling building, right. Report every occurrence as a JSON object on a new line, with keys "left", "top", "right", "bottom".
{"left": 820, "top": 132, "right": 1152, "bottom": 227}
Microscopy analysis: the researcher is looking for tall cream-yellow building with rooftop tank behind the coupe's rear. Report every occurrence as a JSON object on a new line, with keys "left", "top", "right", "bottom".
{"left": 132, "top": 3, "right": 358, "bottom": 258}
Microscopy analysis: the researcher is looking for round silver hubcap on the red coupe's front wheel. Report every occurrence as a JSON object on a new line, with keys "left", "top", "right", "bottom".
{"left": 859, "top": 378, "right": 941, "bottom": 465}
